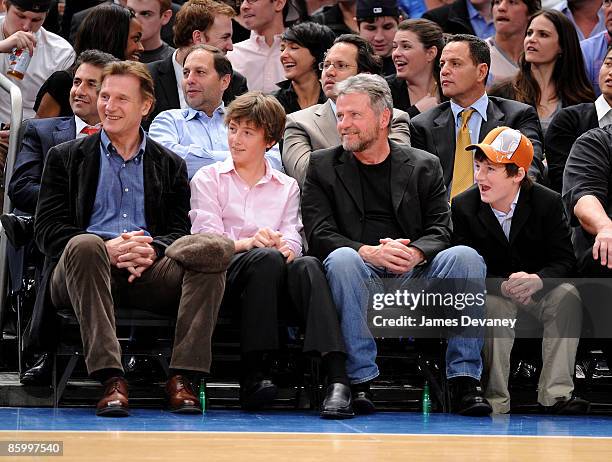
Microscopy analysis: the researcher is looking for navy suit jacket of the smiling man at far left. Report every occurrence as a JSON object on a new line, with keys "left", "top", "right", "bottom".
{"left": 9, "top": 117, "right": 76, "bottom": 215}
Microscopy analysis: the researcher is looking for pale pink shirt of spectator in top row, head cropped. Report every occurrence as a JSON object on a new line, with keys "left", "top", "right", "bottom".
{"left": 227, "top": 31, "right": 285, "bottom": 93}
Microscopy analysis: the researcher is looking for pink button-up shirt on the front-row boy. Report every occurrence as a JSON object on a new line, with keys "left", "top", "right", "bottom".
{"left": 189, "top": 157, "right": 302, "bottom": 257}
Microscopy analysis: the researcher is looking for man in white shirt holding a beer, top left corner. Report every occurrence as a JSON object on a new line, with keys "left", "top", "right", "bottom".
{"left": 0, "top": 0, "right": 75, "bottom": 171}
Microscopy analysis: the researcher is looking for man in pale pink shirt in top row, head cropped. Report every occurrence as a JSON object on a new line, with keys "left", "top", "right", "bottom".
{"left": 227, "top": 0, "right": 286, "bottom": 93}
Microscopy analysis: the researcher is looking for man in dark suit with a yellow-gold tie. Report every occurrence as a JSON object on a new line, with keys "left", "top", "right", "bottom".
{"left": 411, "top": 34, "right": 543, "bottom": 198}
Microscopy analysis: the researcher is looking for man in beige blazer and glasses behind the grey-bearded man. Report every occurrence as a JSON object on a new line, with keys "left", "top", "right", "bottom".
{"left": 282, "top": 34, "right": 410, "bottom": 187}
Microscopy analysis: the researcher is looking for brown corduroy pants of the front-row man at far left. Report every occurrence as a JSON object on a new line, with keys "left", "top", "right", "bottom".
{"left": 51, "top": 234, "right": 225, "bottom": 374}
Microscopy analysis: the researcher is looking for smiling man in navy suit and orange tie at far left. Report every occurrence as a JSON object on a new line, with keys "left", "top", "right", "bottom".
{"left": 9, "top": 50, "right": 117, "bottom": 215}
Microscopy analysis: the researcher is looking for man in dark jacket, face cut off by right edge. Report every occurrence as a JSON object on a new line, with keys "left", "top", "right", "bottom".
{"left": 544, "top": 48, "right": 612, "bottom": 193}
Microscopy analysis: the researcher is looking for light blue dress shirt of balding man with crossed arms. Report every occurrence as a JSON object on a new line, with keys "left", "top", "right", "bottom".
{"left": 149, "top": 103, "right": 283, "bottom": 180}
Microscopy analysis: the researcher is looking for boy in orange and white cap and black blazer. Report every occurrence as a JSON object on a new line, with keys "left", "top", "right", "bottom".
{"left": 451, "top": 127, "right": 589, "bottom": 414}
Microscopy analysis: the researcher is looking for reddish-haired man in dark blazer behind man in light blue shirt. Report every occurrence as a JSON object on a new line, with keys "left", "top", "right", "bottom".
{"left": 143, "top": 0, "right": 248, "bottom": 130}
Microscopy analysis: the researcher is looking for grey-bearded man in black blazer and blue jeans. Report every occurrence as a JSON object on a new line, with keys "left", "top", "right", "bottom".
{"left": 302, "top": 74, "right": 491, "bottom": 415}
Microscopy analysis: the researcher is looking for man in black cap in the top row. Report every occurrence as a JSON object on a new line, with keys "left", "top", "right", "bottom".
{"left": 357, "top": 0, "right": 400, "bottom": 75}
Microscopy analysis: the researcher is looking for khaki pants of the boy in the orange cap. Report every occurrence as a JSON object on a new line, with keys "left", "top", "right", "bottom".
{"left": 483, "top": 284, "right": 582, "bottom": 413}
